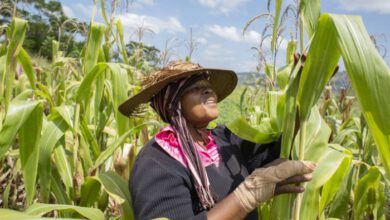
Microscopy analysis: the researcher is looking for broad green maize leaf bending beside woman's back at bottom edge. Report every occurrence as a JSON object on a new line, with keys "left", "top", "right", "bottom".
{"left": 94, "top": 171, "right": 134, "bottom": 220}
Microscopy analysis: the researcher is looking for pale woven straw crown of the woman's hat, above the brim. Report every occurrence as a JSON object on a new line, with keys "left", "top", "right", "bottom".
{"left": 141, "top": 60, "right": 203, "bottom": 87}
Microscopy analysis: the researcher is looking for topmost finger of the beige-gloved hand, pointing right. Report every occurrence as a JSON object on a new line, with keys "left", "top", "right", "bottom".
{"left": 275, "top": 160, "right": 316, "bottom": 180}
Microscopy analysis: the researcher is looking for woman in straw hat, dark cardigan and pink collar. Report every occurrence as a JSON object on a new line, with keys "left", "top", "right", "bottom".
{"left": 119, "top": 61, "right": 315, "bottom": 219}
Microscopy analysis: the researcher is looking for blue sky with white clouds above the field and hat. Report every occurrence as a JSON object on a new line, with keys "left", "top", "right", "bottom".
{"left": 60, "top": 0, "right": 390, "bottom": 72}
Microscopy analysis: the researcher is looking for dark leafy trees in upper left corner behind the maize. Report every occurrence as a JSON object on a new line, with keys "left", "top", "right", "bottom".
{"left": 0, "top": 0, "right": 85, "bottom": 59}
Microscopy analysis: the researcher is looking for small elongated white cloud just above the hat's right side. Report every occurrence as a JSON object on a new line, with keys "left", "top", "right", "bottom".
{"left": 207, "top": 25, "right": 261, "bottom": 43}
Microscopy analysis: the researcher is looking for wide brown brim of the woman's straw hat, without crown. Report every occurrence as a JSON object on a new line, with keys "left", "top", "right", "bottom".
{"left": 119, "top": 68, "right": 237, "bottom": 117}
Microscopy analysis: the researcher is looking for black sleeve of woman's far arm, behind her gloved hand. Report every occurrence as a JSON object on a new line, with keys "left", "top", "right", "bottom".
{"left": 226, "top": 125, "right": 282, "bottom": 173}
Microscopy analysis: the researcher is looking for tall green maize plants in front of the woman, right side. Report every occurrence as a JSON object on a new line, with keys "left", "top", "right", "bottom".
{"left": 228, "top": 0, "right": 390, "bottom": 219}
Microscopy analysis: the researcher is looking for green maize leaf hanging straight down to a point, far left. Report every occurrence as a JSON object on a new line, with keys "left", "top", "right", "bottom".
{"left": 19, "top": 102, "right": 43, "bottom": 205}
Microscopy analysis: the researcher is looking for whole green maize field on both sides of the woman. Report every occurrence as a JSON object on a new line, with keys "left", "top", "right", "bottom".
{"left": 0, "top": 0, "right": 390, "bottom": 220}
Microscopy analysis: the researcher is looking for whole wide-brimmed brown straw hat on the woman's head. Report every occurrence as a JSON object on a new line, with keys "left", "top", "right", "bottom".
{"left": 119, "top": 60, "right": 237, "bottom": 116}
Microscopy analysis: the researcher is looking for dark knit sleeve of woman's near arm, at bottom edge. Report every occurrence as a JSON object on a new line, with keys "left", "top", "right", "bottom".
{"left": 129, "top": 157, "right": 207, "bottom": 220}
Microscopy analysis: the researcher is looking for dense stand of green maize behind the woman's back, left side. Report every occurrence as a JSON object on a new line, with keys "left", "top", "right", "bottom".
{"left": 0, "top": 0, "right": 161, "bottom": 219}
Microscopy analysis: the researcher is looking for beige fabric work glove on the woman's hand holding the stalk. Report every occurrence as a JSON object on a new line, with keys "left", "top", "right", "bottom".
{"left": 234, "top": 159, "right": 316, "bottom": 213}
